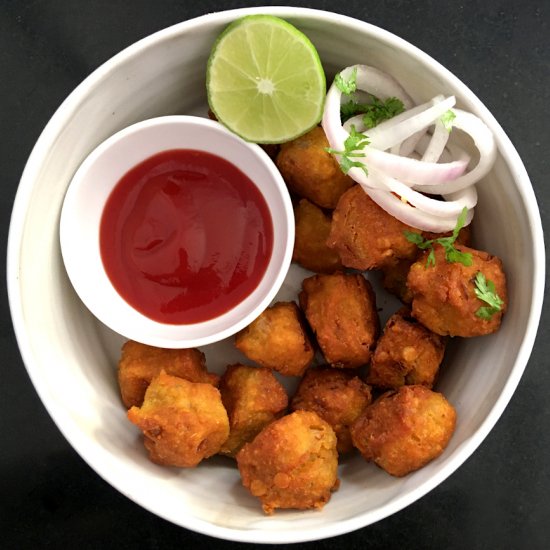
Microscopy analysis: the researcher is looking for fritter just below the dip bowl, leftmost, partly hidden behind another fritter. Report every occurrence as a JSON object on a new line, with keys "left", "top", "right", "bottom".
{"left": 118, "top": 340, "right": 219, "bottom": 409}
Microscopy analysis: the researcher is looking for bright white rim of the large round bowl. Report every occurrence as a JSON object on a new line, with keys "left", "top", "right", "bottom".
{"left": 6, "top": 6, "right": 545, "bottom": 543}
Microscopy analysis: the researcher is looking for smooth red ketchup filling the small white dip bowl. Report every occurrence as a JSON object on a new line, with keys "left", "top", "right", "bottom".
{"left": 99, "top": 149, "right": 273, "bottom": 324}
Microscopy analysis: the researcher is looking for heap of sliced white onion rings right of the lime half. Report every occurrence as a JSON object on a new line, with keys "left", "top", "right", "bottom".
{"left": 322, "top": 65, "right": 496, "bottom": 233}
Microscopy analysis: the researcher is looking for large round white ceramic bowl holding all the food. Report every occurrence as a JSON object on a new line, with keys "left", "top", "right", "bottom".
{"left": 8, "top": 7, "right": 545, "bottom": 543}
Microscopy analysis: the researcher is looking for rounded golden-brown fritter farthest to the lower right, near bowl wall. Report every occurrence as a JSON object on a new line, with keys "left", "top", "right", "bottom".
{"left": 351, "top": 386, "right": 456, "bottom": 477}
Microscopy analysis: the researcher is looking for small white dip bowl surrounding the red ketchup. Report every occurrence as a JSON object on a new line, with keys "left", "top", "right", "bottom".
{"left": 60, "top": 115, "right": 294, "bottom": 348}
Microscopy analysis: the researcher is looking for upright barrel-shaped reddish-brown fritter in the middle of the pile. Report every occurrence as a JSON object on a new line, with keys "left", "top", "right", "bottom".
{"left": 299, "top": 273, "right": 380, "bottom": 368}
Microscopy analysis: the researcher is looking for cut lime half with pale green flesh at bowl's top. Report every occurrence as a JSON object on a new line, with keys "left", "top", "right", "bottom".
{"left": 206, "top": 15, "right": 326, "bottom": 143}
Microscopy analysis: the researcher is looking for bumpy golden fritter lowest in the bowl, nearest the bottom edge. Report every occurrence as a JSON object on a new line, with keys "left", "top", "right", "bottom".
{"left": 237, "top": 411, "right": 339, "bottom": 514}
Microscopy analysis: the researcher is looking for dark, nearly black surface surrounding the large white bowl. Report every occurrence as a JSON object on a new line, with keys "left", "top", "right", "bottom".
{"left": 0, "top": 0, "right": 550, "bottom": 550}
